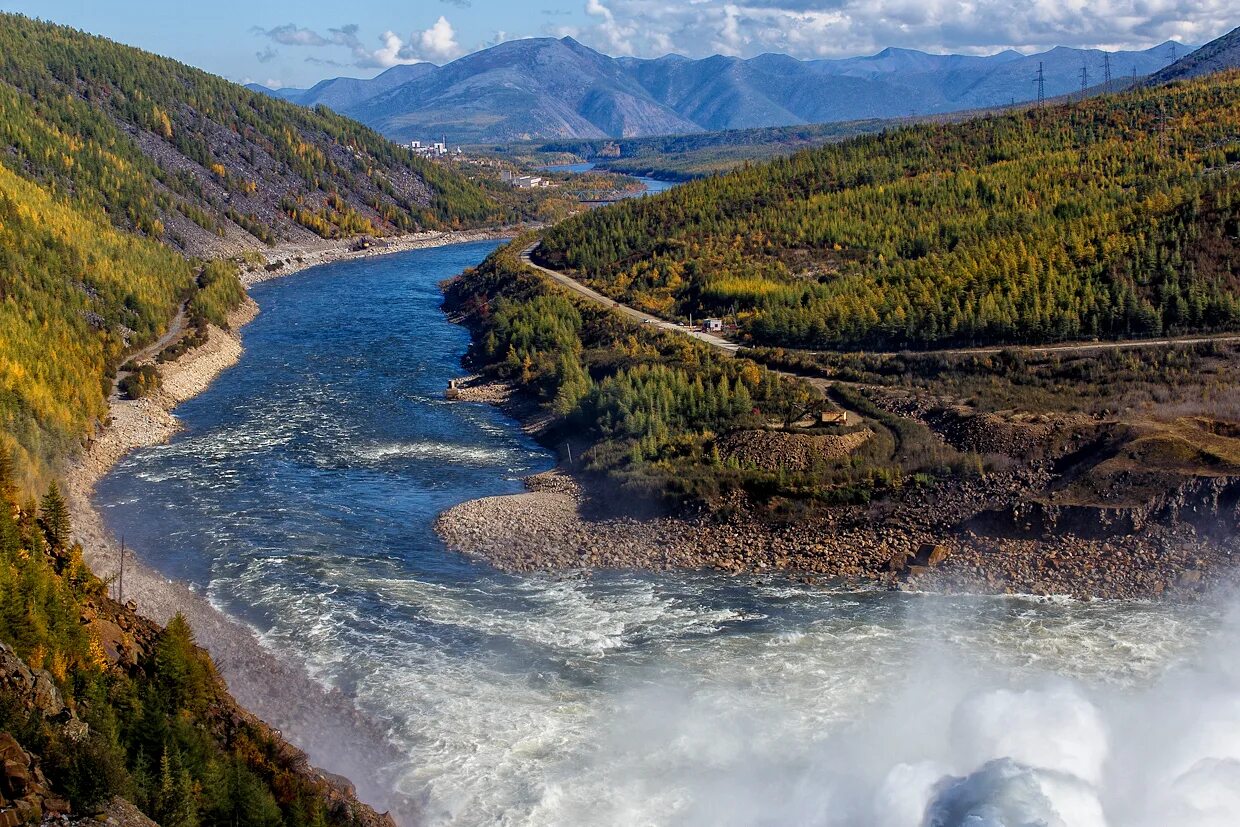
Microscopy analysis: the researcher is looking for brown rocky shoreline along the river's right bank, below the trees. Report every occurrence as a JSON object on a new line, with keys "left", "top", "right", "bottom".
{"left": 435, "top": 377, "right": 1240, "bottom": 599}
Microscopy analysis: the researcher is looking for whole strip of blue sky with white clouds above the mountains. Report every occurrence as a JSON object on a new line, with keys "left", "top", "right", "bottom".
{"left": 0, "top": 0, "right": 1240, "bottom": 87}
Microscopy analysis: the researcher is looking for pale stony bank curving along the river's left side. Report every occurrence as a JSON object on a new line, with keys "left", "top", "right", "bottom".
{"left": 63, "top": 231, "right": 511, "bottom": 823}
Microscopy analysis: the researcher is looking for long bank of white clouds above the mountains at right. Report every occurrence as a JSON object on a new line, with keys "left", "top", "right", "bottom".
{"left": 565, "top": 0, "right": 1236, "bottom": 57}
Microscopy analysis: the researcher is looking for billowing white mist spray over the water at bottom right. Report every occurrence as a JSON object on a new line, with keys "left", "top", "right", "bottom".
{"left": 534, "top": 592, "right": 1240, "bottom": 827}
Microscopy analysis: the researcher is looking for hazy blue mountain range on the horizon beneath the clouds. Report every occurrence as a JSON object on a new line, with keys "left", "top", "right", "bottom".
{"left": 250, "top": 37, "right": 1188, "bottom": 144}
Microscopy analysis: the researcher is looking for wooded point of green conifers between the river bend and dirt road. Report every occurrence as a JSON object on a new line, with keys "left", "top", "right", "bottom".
{"left": 445, "top": 239, "right": 833, "bottom": 505}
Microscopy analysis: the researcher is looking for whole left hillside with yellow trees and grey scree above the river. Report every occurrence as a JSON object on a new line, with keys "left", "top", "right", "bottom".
{"left": 0, "top": 15, "right": 543, "bottom": 486}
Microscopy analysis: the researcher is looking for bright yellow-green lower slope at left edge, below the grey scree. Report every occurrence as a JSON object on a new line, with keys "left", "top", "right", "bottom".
{"left": 0, "top": 158, "right": 193, "bottom": 487}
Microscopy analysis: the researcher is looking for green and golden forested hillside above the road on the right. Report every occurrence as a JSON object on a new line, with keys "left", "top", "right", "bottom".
{"left": 538, "top": 73, "right": 1240, "bottom": 348}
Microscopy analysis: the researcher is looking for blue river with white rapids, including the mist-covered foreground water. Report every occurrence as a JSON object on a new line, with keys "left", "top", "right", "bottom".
{"left": 95, "top": 242, "right": 1240, "bottom": 827}
